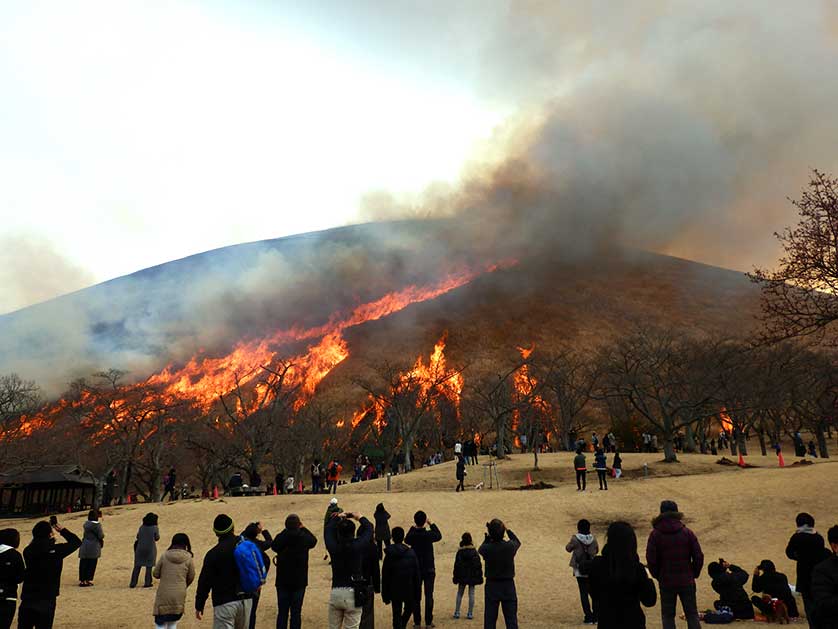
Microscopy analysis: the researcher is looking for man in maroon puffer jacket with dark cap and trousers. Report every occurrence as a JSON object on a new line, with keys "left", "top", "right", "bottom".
{"left": 646, "top": 500, "right": 704, "bottom": 629}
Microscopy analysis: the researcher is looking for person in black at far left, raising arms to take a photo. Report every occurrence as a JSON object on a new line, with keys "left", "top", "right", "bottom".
{"left": 18, "top": 520, "right": 81, "bottom": 629}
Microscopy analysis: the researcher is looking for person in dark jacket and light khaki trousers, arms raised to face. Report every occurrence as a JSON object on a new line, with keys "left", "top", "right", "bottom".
{"left": 324, "top": 513, "right": 373, "bottom": 629}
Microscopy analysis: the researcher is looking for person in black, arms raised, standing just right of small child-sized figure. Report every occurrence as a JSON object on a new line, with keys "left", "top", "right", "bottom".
{"left": 478, "top": 518, "right": 521, "bottom": 629}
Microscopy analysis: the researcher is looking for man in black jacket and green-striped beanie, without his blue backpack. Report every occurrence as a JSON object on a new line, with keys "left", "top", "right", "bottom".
{"left": 195, "top": 513, "right": 251, "bottom": 629}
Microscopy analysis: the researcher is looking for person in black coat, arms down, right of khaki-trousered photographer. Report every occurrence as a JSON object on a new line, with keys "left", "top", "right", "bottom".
{"left": 381, "top": 526, "right": 422, "bottom": 629}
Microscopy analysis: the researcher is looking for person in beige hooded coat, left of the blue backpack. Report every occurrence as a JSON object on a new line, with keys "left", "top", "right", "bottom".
{"left": 152, "top": 533, "right": 195, "bottom": 629}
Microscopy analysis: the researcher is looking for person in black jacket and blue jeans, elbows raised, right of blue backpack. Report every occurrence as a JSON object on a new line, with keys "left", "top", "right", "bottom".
{"left": 271, "top": 513, "right": 317, "bottom": 629}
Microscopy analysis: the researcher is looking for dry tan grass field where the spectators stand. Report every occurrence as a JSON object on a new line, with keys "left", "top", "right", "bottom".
{"left": 0, "top": 454, "right": 838, "bottom": 629}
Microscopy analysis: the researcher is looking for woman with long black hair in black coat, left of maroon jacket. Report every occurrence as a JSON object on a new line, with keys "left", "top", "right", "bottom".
{"left": 586, "top": 522, "right": 657, "bottom": 629}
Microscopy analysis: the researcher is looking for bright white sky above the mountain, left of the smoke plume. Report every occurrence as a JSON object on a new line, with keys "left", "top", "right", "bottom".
{"left": 0, "top": 0, "right": 510, "bottom": 313}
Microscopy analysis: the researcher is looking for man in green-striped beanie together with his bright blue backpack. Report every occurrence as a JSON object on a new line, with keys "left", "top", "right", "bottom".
{"left": 195, "top": 513, "right": 254, "bottom": 629}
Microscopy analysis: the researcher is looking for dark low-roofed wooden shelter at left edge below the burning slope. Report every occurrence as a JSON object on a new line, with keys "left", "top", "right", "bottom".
{"left": 0, "top": 465, "right": 96, "bottom": 515}
